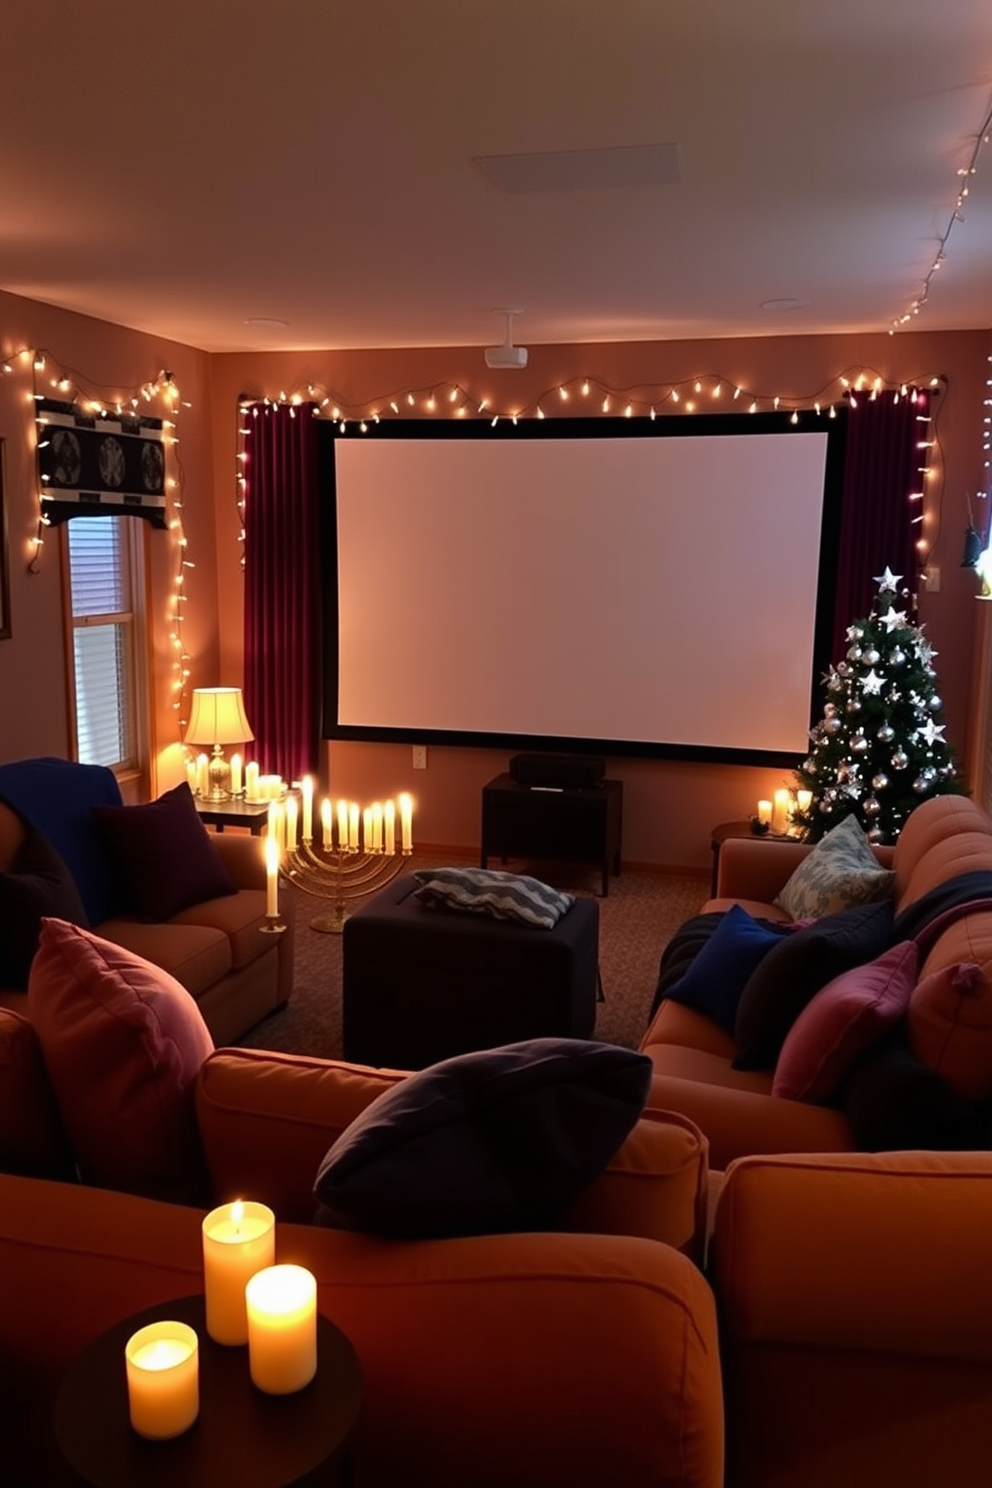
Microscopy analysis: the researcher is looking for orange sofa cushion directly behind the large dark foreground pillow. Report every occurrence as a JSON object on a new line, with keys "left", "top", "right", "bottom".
{"left": 196, "top": 1049, "right": 708, "bottom": 1259}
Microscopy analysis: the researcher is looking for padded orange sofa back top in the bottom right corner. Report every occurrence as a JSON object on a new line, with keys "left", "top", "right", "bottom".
{"left": 711, "top": 1152, "right": 992, "bottom": 1363}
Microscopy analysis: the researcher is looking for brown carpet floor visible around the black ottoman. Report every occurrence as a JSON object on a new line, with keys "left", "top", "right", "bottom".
{"left": 239, "top": 853, "right": 709, "bottom": 1059}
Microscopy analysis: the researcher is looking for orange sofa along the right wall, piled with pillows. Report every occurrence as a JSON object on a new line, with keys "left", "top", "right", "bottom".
{"left": 640, "top": 795, "right": 992, "bottom": 1170}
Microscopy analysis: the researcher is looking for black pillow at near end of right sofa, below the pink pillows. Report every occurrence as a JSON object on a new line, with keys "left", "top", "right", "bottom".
{"left": 843, "top": 1028, "right": 989, "bottom": 1152}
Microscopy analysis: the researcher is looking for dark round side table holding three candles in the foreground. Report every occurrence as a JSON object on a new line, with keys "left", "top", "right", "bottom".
{"left": 55, "top": 1296, "right": 361, "bottom": 1488}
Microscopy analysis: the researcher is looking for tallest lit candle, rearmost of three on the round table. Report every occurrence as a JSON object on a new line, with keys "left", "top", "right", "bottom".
{"left": 202, "top": 1199, "right": 275, "bottom": 1344}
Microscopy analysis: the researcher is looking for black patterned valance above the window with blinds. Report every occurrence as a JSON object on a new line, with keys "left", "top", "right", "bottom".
{"left": 36, "top": 399, "right": 167, "bottom": 527}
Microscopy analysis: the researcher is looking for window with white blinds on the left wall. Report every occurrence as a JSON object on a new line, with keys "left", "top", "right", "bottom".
{"left": 65, "top": 516, "right": 146, "bottom": 774}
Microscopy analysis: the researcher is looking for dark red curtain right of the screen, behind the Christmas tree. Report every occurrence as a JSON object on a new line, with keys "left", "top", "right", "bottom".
{"left": 830, "top": 388, "right": 930, "bottom": 662}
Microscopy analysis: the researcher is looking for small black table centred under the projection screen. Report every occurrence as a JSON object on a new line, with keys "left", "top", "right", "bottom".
{"left": 480, "top": 774, "right": 623, "bottom": 897}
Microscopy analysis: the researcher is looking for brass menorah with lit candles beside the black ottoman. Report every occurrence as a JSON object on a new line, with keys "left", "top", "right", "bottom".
{"left": 279, "top": 777, "right": 413, "bottom": 934}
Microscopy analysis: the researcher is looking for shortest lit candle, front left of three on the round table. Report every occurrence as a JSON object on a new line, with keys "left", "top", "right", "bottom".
{"left": 123, "top": 1323, "right": 199, "bottom": 1440}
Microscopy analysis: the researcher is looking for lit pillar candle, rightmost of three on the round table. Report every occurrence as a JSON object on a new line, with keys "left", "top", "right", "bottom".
{"left": 245, "top": 1265, "right": 317, "bottom": 1394}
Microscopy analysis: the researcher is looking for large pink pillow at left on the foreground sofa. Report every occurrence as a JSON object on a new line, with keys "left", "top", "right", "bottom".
{"left": 28, "top": 920, "right": 213, "bottom": 1202}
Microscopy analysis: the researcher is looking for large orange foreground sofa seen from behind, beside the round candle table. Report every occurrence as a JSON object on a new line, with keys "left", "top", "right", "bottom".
{"left": 0, "top": 1012, "right": 723, "bottom": 1488}
